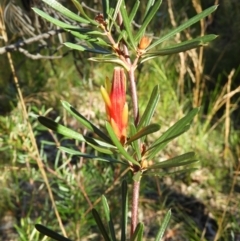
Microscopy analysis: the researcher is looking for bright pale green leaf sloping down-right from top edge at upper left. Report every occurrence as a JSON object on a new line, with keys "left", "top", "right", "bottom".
{"left": 42, "top": 0, "right": 90, "bottom": 23}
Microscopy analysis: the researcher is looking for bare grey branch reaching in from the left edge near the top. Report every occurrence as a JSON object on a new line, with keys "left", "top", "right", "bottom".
{"left": 0, "top": 29, "right": 65, "bottom": 54}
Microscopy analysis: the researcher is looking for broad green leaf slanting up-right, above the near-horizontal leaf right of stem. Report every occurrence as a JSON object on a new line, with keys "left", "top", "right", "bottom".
{"left": 146, "top": 108, "right": 199, "bottom": 160}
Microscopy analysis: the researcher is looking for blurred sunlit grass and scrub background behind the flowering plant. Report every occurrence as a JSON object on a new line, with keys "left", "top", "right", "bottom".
{"left": 0, "top": 0, "right": 240, "bottom": 241}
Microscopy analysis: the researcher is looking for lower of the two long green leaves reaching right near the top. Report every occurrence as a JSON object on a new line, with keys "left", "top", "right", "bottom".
{"left": 140, "top": 34, "right": 217, "bottom": 60}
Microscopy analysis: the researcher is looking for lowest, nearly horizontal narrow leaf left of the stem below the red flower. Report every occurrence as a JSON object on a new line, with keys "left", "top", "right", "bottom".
{"left": 58, "top": 146, "right": 126, "bottom": 165}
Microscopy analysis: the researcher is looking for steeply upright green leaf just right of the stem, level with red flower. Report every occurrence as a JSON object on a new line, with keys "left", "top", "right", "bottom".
{"left": 137, "top": 85, "right": 160, "bottom": 130}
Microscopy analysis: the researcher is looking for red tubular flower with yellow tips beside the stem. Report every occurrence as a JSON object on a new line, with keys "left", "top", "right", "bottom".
{"left": 101, "top": 67, "right": 128, "bottom": 144}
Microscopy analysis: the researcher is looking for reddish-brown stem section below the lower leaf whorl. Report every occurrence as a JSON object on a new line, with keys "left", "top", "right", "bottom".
{"left": 131, "top": 180, "right": 140, "bottom": 237}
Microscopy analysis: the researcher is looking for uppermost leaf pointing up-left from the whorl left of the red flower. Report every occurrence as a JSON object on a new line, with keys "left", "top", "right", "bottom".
{"left": 62, "top": 101, "right": 112, "bottom": 144}
